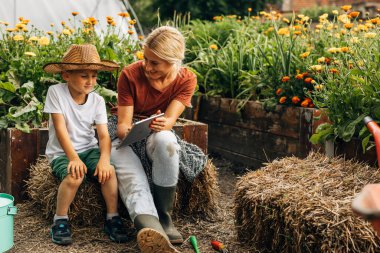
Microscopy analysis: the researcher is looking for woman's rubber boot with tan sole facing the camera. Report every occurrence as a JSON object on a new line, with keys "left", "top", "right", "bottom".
{"left": 134, "top": 214, "right": 179, "bottom": 253}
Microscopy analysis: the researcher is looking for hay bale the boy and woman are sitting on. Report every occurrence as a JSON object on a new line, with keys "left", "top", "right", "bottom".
{"left": 26, "top": 157, "right": 219, "bottom": 226}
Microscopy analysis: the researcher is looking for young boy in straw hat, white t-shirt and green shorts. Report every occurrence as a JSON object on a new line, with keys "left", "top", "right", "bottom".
{"left": 43, "top": 45, "right": 127, "bottom": 245}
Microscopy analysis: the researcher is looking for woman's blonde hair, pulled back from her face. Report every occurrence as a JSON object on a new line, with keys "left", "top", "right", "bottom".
{"left": 144, "top": 26, "right": 185, "bottom": 70}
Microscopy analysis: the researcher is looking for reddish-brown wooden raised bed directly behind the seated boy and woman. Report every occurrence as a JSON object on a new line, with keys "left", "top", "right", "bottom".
{"left": 0, "top": 119, "right": 208, "bottom": 201}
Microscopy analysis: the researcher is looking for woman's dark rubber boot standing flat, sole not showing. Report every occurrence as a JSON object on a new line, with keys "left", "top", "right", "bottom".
{"left": 153, "top": 184, "right": 183, "bottom": 244}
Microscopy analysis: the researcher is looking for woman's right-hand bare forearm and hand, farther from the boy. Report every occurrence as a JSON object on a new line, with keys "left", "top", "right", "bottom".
{"left": 150, "top": 100, "right": 185, "bottom": 132}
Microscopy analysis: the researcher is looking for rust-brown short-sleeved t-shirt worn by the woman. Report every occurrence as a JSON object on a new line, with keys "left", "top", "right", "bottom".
{"left": 117, "top": 61, "right": 197, "bottom": 116}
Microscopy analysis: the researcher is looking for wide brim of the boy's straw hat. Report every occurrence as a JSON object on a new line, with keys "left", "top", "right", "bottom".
{"left": 43, "top": 60, "right": 119, "bottom": 73}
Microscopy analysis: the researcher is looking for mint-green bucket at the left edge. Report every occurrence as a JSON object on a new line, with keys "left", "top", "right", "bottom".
{"left": 0, "top": 193, "right": 17, "bottom": 252}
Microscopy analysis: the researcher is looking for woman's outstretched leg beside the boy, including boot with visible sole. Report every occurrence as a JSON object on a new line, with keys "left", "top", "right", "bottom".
{"left": 111, "top": 141, "right": 178, "bottom": 253}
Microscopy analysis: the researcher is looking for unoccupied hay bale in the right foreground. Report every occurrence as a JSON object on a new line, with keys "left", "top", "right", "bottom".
{"left": 235, "top": 153, "right": 380, "bottom": 252}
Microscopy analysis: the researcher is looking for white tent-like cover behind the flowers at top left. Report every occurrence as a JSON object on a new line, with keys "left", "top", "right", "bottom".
{"left": 0, "top": 0, "right": 143, "bottom": 37}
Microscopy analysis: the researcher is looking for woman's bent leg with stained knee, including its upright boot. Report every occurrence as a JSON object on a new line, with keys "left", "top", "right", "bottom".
{"left": 147, "top": 131, "right": 183, "bottom": 243}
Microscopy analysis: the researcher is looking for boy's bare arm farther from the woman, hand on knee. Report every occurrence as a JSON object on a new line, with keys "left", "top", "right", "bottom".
{"left": 51, "top": 113, "right": 87, "bottom": 178}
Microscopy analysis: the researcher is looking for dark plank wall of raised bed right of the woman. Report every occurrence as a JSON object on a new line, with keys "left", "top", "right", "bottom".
{"left": 185, "top": 97, "right": 326, "bottom": 168}
